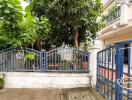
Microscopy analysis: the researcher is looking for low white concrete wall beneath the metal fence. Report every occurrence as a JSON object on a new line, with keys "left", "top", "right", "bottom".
{"left": 0, "top": 72, "right": 90, "bottom": 89}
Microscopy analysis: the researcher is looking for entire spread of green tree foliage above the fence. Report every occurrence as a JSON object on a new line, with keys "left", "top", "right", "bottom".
{"left": 0, "top": 0, "right": 100, "bottom": 48}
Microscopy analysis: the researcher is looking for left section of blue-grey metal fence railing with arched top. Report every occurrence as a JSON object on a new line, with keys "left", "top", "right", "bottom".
{"left": 0, "top": 48, "right": 43, "bottom": 71}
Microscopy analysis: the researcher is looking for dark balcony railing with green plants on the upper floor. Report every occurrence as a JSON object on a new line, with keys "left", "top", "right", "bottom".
{"left": 99, "top": 7, "right": 121, "bottom": 29}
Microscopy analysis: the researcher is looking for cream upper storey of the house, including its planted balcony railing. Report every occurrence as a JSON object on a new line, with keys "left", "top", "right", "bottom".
{"left": 97, "top": 0, "right": 132, "bottom": 49}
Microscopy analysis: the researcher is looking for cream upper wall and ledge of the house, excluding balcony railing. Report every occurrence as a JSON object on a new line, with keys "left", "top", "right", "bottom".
{"left": 97, "top": 0, "right": 132, "bottom": 49}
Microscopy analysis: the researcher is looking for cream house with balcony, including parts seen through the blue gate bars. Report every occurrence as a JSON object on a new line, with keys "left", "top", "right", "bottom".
{"left": 97, "top": 0, "right": 132, "bottom": 80}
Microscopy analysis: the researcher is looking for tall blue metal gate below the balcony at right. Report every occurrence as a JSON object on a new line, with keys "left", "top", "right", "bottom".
{"left": 96, "top": 41, "right": 132, "bottom": 100}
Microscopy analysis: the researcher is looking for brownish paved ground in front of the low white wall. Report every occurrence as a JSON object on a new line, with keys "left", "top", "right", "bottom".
{"left": 0, "top": 88, "right": 103, "bottom": 100}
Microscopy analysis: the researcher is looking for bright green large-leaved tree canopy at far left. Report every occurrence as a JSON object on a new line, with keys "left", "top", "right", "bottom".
{"left": 0, "top": 0, "right": 36, "bottom": 46}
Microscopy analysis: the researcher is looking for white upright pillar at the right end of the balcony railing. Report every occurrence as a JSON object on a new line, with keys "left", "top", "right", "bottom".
{"left": 120, "top": 0, "right": 129, "bottom": 25}
